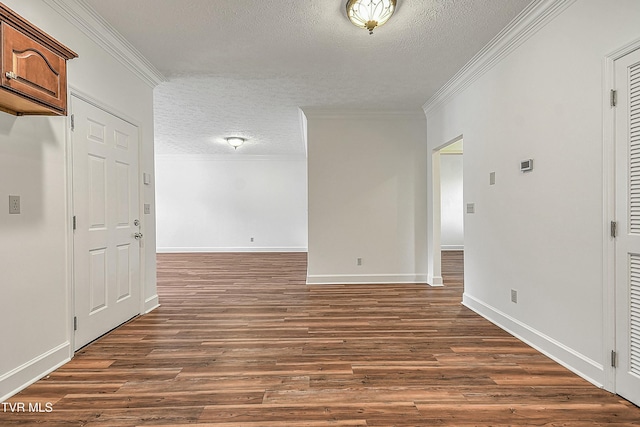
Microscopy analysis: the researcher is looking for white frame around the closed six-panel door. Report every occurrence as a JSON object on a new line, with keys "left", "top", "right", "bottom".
{"left": 65, "top": 86, "right": 146, "bottom": 359}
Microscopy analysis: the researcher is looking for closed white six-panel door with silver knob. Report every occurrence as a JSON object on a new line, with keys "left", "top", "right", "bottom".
{"left": 71, "top": 97, "right": 141, "bottom": 350}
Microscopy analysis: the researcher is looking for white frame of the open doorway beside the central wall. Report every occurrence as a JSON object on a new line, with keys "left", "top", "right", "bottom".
{"left": 427, "top": 134, "right": 464, "bottom": 286}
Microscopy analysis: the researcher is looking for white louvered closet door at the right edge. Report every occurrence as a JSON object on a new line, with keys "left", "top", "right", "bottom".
{"left": 615, "top": 46, "right": 640, "bottom": 405}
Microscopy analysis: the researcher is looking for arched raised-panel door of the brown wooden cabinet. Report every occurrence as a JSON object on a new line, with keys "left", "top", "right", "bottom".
{"left": 2, "top": 23, "right": 67, "bottom": 112}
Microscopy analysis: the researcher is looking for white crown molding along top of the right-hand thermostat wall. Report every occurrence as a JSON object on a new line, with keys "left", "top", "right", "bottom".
{"left": 422, "top": 0, "right": 576, "bottom": 115}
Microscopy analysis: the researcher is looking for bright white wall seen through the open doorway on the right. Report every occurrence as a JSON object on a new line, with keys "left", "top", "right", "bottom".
{"left": 440, "top": 153, "right": 464, "bottom": 250}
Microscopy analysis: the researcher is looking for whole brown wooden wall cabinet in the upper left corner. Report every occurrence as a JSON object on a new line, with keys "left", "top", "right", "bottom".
{"left": 0, "top": 3, "right": 78, "bottom": 116}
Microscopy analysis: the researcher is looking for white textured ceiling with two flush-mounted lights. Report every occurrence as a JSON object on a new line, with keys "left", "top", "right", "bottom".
{"left": 85, "top": 0, "right": 531, "bottom": 155}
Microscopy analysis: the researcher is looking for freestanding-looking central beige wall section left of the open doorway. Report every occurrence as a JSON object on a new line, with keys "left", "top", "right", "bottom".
{"left": 305, "top": 110, "right": 427, "bottom": 283}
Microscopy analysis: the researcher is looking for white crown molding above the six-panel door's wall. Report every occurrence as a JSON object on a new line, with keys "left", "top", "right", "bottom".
{"left": 44, "top": 0, "right": 166, "bottom": 88}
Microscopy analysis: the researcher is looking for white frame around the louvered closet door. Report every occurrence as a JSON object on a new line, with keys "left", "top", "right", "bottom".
{"left": 602, "top": 39, "right": 640, "bottom": 393}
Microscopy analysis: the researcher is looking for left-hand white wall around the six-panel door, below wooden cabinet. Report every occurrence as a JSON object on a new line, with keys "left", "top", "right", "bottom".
{"left": 0, "top": 0, "right": 157, "bottom": 401}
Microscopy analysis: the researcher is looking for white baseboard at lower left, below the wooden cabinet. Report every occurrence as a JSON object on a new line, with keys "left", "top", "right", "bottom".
{"left": 0, "top": 341, "right": 71, "bottom": 402}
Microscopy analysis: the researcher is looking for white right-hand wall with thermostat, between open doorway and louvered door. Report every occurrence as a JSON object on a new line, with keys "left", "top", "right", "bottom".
{"left": 426, "top": 0, "right": 640, "bottom": 390}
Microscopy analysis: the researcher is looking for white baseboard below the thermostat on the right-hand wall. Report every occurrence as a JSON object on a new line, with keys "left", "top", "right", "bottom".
{"left": 462, "top": 293, "right": 604, "bottom": 388}
